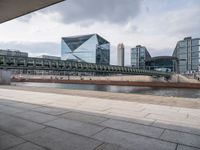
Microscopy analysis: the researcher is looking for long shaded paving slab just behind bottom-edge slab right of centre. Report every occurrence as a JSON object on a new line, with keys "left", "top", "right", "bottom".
{"left": 101, "top": 119, "right": 164, "bottom": 138}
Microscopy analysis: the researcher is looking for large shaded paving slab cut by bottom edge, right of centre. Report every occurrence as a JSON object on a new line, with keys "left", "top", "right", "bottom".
{"left": 93, "top": 129, "right": 176, "bottom": 150}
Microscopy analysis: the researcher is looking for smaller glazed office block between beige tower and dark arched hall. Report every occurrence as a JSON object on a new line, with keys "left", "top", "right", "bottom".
{"left": 131, "top": 45, "right": 151, "bottom": 69}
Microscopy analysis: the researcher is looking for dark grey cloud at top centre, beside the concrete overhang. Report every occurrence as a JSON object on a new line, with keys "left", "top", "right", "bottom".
{"left": 44, "top": 0, "right": 142, "bottom": 24}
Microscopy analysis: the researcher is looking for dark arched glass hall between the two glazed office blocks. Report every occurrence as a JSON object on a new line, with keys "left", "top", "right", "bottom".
{"left": 145, "top": 56, "right": 178, "bottom": 72}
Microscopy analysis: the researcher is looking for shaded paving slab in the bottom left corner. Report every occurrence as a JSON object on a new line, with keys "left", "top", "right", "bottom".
{"left": 0, "top": 134, "right": 25, "bottom": 150}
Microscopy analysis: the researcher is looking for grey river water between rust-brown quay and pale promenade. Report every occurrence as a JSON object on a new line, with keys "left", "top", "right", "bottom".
{"left": 12, "top": 82, "right": 200, "bottom": 98}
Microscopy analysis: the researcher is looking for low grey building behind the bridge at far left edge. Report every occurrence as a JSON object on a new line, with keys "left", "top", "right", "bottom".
{"left": 0, "top": 50, "right": 28, "bottom": 57}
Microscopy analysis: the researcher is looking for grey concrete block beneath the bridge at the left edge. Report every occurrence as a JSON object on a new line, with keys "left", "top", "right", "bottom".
{"left": 0, "top": 70, "right": 11, "bottom": 85}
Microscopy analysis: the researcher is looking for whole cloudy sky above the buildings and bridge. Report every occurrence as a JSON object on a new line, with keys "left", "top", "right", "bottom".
{"left": 0, "top": 0, "right": 200, "bottom": 65}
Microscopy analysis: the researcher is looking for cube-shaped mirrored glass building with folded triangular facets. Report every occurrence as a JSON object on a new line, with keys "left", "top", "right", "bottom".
{"left": 61, "top": 34, "right": 110, "bottom": 65}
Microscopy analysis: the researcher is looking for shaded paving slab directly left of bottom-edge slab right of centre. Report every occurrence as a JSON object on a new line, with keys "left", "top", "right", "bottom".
{"left": 45, "top": 118, "right": 103, "bottom": 136}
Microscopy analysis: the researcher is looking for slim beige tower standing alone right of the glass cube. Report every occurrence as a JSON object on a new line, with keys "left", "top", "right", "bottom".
{"left": 117, "top": 43, "right": 124, "bottom": 66}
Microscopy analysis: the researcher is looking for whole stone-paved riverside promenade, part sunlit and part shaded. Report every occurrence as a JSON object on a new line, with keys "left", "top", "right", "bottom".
{"left": 0, "top": 86, "right": 200, "bottom": 150}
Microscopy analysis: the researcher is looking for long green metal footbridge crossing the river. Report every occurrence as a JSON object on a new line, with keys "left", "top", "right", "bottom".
{"left": 0, "top": 55, "right": 171, "bottom": 79}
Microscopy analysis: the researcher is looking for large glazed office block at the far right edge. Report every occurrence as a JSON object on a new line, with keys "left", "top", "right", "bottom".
{"left": 173, "top": 37, "right": 200, "bottom": 73}
